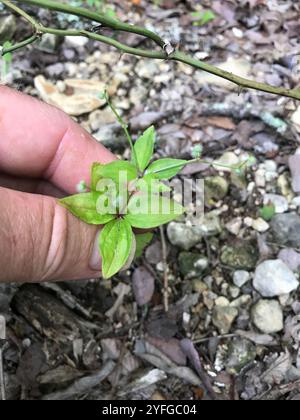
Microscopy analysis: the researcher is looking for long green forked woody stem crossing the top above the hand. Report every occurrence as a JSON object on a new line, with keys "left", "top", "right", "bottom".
{"left": 0, "top": 0, "right": 300, "bottom": 100}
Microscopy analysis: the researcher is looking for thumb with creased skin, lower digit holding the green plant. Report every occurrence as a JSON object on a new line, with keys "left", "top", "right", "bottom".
{"left": 0, "top": 188, "right": 101, "bottom": 282}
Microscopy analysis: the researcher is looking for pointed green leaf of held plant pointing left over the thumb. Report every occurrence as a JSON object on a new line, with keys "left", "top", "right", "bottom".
{"left": 59, "top": 192, "right": 116, "bottom": 225}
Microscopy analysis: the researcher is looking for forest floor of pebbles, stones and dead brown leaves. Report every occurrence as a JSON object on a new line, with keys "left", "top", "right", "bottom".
{"left": 0, "top": 0, "right": 300, "bottom": 400}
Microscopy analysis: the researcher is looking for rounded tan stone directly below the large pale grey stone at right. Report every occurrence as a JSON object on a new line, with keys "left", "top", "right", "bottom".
{"left": 251, "top": 299, "right": 283, "bottom": 334}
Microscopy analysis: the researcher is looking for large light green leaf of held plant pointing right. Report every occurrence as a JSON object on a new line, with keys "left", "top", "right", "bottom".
{"left": 125, "top": 193, "right": 184, "bottom": 229}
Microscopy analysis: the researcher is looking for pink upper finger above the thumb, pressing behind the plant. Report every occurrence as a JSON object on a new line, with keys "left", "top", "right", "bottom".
{"left": 0, "top": 86, "right": 115, "bottom": 193}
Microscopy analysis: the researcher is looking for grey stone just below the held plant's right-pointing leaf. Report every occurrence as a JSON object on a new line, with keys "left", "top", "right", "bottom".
{"left": 167, "top": 222, "right": 202, "bottom": 251}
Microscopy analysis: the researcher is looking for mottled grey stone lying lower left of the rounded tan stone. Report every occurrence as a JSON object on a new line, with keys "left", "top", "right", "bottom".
{"left": 226, "top": 338, "right": 256, "bottom": 375}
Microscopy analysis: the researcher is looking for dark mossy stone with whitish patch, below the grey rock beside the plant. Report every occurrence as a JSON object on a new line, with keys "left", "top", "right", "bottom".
{"left": 178, "top": 252, "right": 209, "bottom": 279}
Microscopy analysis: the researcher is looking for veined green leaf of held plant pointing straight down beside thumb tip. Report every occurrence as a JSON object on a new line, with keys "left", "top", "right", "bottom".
{"left": 99, "top": 219, "right": 133, "bottom": 279}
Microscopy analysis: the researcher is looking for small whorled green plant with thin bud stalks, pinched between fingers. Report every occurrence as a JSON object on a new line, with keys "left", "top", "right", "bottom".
{"left": 60, "top": 92, "right": 247, "bottom": 278}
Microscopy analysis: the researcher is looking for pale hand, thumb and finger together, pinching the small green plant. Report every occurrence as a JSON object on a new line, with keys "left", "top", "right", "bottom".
{"left": 0, "top": 86, "right": 115, "bottom": 282}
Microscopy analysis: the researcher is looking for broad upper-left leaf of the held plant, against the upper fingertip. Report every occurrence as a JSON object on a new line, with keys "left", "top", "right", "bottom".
{"left": 91, "top": 160, "right": 138, "bottom": 191}
